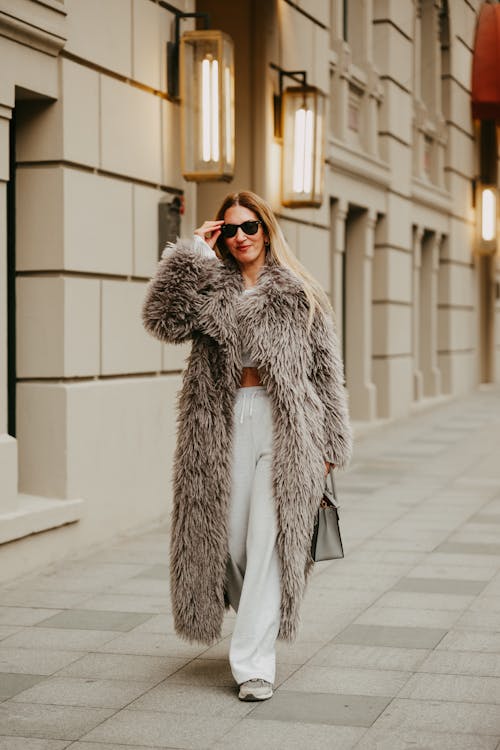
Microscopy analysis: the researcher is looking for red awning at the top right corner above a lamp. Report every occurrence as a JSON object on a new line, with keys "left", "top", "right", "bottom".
{"left": 472, "top": 3, "right": 500, "bottom": 122}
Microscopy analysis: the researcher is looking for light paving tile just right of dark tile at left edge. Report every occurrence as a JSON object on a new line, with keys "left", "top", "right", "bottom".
{"left": 13, "top": 676, "right": 151, "bottom": 708}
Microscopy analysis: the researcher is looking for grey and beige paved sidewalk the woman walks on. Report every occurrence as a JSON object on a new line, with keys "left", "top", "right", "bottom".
{"left": 0, "top": 389, "right": 500, "bottom": 750}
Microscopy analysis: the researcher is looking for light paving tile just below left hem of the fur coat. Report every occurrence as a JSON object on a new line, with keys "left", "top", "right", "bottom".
{"left": 95, "top": 632, "right": 207, "bottom": 659}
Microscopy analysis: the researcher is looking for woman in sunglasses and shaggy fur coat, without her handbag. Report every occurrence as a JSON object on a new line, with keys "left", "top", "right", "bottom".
{"left": 143, "top": 192, "right": 351, "bottom": 700}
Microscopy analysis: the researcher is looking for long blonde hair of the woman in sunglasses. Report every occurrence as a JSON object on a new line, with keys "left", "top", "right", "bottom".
{"left": 216, "top": 190, "right": 332, "bottom": 328}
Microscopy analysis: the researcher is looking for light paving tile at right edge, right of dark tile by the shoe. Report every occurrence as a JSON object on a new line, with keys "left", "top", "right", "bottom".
{"left": 375, "top": 698, "right": 500, "bottom": 736}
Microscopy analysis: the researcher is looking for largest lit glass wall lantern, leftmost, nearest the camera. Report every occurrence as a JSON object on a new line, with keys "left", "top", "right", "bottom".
{"left": 160, "top": 0, "right": 234, "bottom": 182}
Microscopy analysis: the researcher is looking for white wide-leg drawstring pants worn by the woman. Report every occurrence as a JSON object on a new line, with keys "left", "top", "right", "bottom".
{"left": 227, "top": 386, "right": 280, "bottom": 684}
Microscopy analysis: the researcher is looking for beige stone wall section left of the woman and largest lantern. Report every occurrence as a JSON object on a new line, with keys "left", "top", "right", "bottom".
{"left": 0, "top": 0, "right": 196, "bottom": 577}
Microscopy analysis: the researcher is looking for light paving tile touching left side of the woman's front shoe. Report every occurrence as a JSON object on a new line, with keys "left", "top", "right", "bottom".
{"left": 128, "top": 681, "right": 255, "bottom": 717}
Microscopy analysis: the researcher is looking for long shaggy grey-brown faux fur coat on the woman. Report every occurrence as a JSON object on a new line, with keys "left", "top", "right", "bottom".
{"left": 143, "top": 241, "right": 351, "bottom": 643}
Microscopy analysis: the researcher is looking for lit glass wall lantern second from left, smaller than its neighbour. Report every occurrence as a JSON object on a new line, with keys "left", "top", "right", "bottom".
{"left": 271, "top": 63, "right": 326, "bottom": 208}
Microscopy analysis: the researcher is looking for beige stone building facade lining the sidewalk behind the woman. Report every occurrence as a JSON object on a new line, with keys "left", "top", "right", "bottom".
{"left": 0, "top": 0, "right": 500, "bottom": 579}
